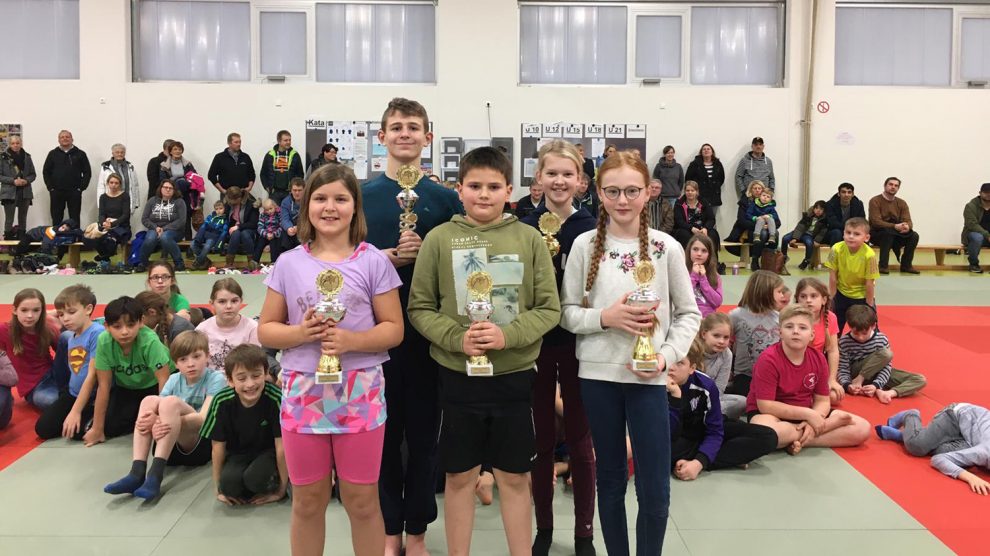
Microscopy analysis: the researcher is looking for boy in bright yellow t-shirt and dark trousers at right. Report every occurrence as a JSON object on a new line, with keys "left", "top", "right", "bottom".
{"left": 825, "top": 217, "right": 880, "bottom": 335}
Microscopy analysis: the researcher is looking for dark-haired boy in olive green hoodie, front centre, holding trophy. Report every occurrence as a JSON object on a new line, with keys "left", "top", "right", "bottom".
{"left": 408, "top": 147, "right": 560, "bottom": 555}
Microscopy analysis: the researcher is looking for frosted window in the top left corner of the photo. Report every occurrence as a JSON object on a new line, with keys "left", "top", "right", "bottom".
{"left": 0, "top": 0, "right": 79, "bottom": 79}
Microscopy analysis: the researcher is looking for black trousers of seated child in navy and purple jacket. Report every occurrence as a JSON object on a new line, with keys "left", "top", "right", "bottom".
{"left": 670, "top": 419, "right": 777, "bottom": 471}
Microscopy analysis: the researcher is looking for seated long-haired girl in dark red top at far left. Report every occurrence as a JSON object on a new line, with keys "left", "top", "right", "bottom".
{"left": 0, "top": 288, "right": 61, "bottom": 412}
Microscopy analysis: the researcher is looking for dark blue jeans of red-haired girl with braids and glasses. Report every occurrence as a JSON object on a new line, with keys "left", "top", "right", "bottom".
{"left": 581, "top": 378, "right": 670, "bottom": 556}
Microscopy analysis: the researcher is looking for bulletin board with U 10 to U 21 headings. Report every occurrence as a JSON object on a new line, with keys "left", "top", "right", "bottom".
{"left": 519, "top": 122, "right": 646, "bottom": 187}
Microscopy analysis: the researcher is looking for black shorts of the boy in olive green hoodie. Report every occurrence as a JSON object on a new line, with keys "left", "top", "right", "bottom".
{"left": 439, "top": 405, "right": 536, "bottom": 473}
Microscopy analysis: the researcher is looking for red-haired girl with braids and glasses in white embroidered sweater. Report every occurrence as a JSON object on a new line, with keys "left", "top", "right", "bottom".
{"left": 561, "top": 152, "right": 701, "bottom": 555}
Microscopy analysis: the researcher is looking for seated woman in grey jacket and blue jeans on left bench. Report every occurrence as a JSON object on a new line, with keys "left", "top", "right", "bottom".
{"left": 135, "top": 180, "right": 187, "bottom": 272}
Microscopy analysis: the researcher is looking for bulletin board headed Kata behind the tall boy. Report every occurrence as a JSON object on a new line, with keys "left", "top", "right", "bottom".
{"left": 306, "top": 117, "right": 433, "bottom": 181}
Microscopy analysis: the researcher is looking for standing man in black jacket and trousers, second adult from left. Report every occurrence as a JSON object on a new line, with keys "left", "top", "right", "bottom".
{"left": 41, "top": 129, "right": 93, "bottom": 223}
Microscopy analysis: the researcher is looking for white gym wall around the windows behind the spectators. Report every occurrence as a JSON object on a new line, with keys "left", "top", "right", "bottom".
{"left": 0, "top": 0, "right": 990, "bottom": 242}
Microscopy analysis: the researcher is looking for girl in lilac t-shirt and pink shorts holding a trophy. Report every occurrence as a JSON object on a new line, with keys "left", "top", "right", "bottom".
{"left": 258, "top": 164, "right": 403, "bottom": 556}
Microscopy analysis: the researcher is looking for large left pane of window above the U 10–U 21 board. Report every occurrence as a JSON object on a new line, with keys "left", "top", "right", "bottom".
{"left": 519, "top": 6, "right": 627, "bottom": 85}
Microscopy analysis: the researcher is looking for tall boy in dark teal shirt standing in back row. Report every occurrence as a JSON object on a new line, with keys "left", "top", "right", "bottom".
{"left": 361, "top": 98, "right": 462, "bottom": 554}
